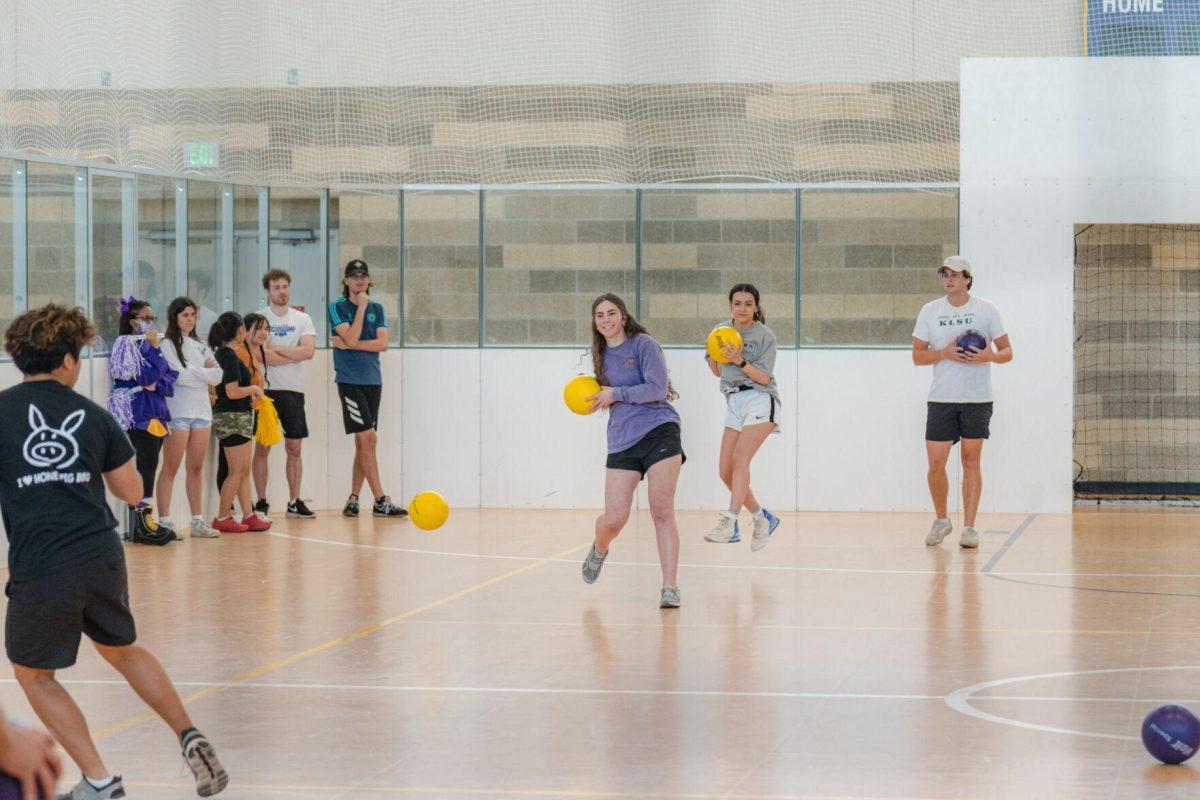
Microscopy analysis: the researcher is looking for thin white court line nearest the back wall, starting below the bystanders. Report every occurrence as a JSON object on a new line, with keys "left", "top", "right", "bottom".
{"left": 266, "top": 530, "right": 1200, "bottom": 579}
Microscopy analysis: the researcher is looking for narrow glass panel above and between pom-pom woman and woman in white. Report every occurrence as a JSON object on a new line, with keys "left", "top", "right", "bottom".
{"left": 133, "top": 175, "right": 180, "bottom": 316}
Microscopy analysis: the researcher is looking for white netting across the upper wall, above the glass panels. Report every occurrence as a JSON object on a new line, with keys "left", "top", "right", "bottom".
{"left": 0, "top": 0, "right": 1085, "bottom": 185}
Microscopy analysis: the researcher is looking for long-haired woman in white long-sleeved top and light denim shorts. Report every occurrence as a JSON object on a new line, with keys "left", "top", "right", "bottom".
{"left": 156, "top": 297, "right": 222, "bottom": 539}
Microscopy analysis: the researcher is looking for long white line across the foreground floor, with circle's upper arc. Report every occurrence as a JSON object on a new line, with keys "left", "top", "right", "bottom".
{"left": 0, "top": 681, "right": 1200, "bottom": 705}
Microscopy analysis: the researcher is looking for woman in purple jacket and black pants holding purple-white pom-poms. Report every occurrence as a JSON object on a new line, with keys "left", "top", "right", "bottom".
{"left": 108, "top": 295, "right": 179, "bottom": 543}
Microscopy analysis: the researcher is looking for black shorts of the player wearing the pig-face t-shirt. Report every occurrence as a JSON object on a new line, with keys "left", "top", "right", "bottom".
{"left": 5, "top": 551, "right": 138, "bottom": 669}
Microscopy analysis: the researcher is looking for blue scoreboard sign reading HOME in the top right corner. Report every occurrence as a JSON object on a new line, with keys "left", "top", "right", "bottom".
{"left": 1084, "top": 0, "right": 1200, "bottom": 55}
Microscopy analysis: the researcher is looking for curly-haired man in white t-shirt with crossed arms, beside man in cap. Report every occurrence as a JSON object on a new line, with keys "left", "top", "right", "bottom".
{"left": 253, "top": 270, "right": 317, "bottom": 519}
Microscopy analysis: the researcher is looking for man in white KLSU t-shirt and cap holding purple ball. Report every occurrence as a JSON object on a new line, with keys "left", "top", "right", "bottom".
{"left": 912, "top": 255, "right": 1013, "bottom": 547}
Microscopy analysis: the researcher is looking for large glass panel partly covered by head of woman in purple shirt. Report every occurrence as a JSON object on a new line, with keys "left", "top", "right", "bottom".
{"left": 484, "top": 190, "right": 637, "bottom": 344}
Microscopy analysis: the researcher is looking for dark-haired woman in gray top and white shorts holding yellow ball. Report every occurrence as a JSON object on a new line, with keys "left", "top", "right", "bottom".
{"left": 704, "top": 283, "right": 780, "bottom": 551}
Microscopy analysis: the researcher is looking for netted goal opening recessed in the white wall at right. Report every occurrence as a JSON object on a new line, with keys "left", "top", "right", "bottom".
{"left": 1075, "top": 224, "right": 1200, "bottom": 499}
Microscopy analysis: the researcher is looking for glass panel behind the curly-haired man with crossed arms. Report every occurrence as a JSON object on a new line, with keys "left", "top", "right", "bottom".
{"left": 264, "top": 187, "right": 329, "bottom": 347}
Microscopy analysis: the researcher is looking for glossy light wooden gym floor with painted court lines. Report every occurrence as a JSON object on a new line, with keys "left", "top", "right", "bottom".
{"left": 0, "top": 507, "right": 1200, "bottom": 800}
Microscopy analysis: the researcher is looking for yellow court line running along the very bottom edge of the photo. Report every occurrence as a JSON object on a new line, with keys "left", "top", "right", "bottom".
{"left": 125, "top": 781, "right": 964, "bottom": 800}
